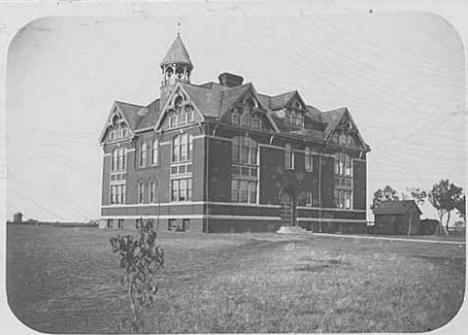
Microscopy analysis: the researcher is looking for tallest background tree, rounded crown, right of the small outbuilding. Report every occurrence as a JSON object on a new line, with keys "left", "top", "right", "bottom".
{"left": 429, "top": 179, "right": 463, "bottom": 235}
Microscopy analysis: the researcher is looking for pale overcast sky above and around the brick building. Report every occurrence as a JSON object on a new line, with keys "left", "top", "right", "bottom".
{"left": 7, "top": 8, "right": 466, "bottom": 221}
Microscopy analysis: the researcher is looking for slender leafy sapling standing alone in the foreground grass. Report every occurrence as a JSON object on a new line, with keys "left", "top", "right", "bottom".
{"left": 110, "top": 219, "right": 164, "bottom": 334}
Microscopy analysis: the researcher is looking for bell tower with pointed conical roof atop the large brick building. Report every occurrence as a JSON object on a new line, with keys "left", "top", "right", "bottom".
{"left": 160, "top": 28, "right": 193, "bottom": 107}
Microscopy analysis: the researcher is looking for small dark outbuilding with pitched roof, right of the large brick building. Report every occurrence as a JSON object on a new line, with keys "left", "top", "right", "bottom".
{"left": 374, "top": 200, "right": 422, "bottom": 235}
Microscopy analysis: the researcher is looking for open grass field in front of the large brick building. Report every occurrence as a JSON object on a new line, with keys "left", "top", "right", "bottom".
{"left": 7, "top": 225, "right": 465, "bottom": 333}
